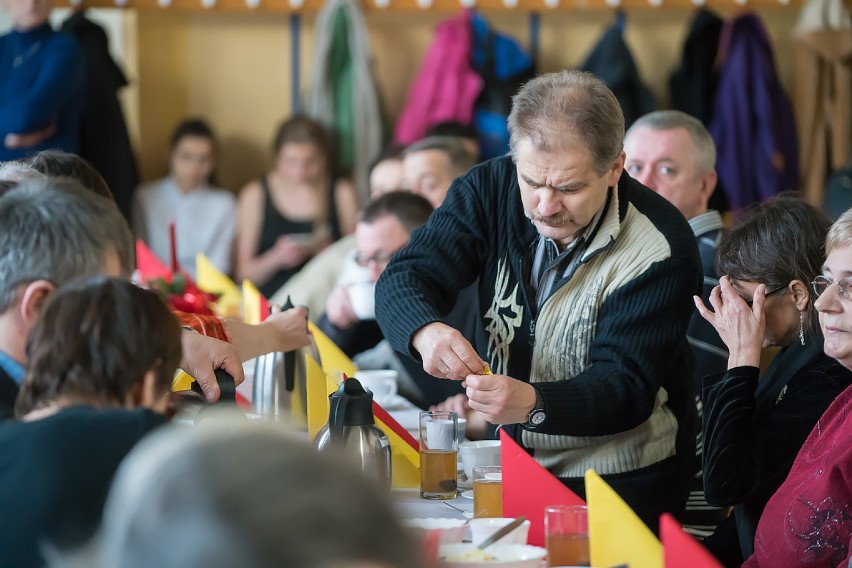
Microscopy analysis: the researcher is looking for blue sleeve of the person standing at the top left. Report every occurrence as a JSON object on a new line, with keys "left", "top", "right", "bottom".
{"left": 0, "top": 34, "right": 84, "bottom": 136}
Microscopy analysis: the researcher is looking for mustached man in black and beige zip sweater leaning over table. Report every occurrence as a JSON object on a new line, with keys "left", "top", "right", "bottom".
{"left": 376, "top": 71, "right": 701, "bottom": 530}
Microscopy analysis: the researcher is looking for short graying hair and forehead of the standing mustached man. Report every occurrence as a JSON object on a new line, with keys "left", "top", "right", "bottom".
{"left": 509, "top": 71, "right": 624, "bottom": 175}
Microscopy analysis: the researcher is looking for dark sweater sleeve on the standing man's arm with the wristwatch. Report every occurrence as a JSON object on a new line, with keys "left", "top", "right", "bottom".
{"left": 536, "top": 254, "right": 700, "bottom": 436}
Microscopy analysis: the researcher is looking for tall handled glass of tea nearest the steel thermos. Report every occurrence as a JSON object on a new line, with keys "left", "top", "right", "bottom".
{"left": 420, "top": 410, "right": 459, "bottom": 499}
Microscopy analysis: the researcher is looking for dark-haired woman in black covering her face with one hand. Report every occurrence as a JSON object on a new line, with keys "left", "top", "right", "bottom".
{"left": 695, "top": 197, "right": 852, "bottom": 566}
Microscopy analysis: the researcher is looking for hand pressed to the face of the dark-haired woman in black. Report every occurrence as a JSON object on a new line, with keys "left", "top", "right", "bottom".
{"left": 692, "top": 276, "right": 766, "bottom": 369}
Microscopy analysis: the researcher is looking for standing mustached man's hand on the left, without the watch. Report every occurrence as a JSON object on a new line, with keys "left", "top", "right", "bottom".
{"left": 411, "top": 322, "right": 485, "bottom": 381}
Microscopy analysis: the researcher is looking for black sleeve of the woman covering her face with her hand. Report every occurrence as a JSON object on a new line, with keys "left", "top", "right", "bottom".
{"left": 701, "top": 367, "right": 840, "bottom": 507}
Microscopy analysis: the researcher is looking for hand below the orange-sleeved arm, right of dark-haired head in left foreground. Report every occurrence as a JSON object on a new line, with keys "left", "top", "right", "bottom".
{"left": 180, "top": 329, "right": 245, "bottom": 402}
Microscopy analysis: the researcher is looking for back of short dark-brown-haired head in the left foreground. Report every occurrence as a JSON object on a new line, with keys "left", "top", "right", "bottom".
{"left": 15, "top": 277, "right": 181, "bottom": 416}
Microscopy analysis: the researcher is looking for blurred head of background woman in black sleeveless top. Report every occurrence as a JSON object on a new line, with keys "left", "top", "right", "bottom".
{"left": 273, "top": 115, "right": 332, "bottom": 185}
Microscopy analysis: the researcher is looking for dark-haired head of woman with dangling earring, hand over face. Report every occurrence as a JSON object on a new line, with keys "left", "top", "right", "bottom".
{"left": 716, "top": 195, "right": 831, "bottom": 345}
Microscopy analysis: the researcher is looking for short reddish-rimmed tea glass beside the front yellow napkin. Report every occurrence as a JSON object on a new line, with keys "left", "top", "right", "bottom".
{"left": 544, "top": 505, "right": 591, "bottom": 566}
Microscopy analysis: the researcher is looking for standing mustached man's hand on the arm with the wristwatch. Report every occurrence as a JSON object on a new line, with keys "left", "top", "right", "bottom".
{"left": 465, "top": 374, "right": 535, "bottom": 424}
